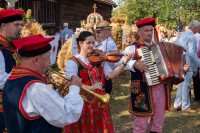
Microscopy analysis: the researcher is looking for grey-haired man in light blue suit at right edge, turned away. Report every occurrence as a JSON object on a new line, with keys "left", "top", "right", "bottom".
{"left": 174, "top": 20, "right": 200, "bottom": 113}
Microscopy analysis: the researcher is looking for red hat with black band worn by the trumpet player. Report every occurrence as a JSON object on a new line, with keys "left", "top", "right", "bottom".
{"left": 12, "top": 35, "right": 54, "bottom": 57}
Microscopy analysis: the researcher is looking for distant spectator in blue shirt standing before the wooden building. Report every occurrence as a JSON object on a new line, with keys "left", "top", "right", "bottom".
{"left": 60, "top": 23, "right": 73, "bottom": 46}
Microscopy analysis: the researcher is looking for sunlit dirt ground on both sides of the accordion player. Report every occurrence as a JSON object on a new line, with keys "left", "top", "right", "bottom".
{"left": 110, "top": 72, "right": 200, "bottom": 133}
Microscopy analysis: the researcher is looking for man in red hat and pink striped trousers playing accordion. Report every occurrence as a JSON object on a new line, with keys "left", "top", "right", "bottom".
{"left": 119, "top": 18, "right": 189, "bottom": 133}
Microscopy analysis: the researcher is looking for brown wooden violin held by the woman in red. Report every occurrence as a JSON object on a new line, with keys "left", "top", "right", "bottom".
{"left": 88, "top": 49, "right": 142, "bottom": 64}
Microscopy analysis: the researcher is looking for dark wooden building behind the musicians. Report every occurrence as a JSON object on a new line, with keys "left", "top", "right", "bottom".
{"left": 0, "top": 0, "right": 117, "bottom": 34}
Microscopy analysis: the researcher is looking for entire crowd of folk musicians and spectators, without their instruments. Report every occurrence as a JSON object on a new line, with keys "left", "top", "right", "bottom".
{"left": 0, "top": 9, "right": 200, "bottom": 133}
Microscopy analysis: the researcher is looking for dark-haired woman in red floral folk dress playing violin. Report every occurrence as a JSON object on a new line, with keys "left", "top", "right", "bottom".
{"left": 64, "top": 31, "right": 132, "bottom": 133}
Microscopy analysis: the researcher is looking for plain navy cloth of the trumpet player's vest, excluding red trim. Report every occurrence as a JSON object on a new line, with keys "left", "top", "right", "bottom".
{"left": 3, "top": 76, "right": 62, "bottom": 133}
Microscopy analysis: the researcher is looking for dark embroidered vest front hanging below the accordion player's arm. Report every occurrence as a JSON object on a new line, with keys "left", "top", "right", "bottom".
{"left": 129, "top": 44, "right": 154, "bottom": 116}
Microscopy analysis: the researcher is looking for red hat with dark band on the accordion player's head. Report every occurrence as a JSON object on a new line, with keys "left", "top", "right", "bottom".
{"left": 135, "top": 18, "right": 156, "bottom": 28}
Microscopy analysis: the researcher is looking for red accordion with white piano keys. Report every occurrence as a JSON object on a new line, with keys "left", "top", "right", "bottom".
{"left": 137, "top": 42, "right": 185, "bottom": 86}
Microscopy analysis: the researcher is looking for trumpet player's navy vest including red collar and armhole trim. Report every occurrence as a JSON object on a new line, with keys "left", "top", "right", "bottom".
{"left": 3, "top": 67, "right": 62, "bottom": 133}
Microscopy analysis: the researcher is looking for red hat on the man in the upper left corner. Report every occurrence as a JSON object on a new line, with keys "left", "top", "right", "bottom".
{"left": 0, "top": 8, "right": 24, "bottom": 23}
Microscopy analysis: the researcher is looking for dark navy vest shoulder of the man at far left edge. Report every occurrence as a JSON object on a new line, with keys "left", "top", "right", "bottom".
{"left": 0, "top": 45, "right": 16, "bottom": 73}
